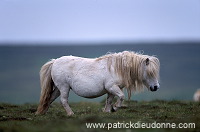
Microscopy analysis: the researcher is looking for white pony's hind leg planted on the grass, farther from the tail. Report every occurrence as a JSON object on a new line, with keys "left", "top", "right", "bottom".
{"left": 59, "top": 86, "right": 74, "bottom": 116}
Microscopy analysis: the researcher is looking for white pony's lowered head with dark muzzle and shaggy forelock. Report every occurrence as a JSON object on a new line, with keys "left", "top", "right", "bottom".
{"left": 142, "top": 57, "right": 160, "bottom": 91}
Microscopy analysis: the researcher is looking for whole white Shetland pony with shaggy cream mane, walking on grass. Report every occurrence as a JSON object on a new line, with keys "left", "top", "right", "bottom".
{"left": 36, "top": 51, "right": 160, "bottom": 115}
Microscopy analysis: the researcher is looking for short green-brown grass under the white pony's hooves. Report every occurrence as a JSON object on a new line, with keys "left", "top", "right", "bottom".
{"left": 0, "top": 100, "right": 200, "bottom": 132}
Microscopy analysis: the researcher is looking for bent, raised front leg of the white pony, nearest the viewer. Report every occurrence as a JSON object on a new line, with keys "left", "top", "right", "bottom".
{"left": 107, "top": 85, "right": 125, "bottom": 111}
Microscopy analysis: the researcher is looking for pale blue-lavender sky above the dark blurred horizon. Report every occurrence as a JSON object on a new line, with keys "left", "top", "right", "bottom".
{"left": 0, "top": 0, "right": 200, "bottom": 42}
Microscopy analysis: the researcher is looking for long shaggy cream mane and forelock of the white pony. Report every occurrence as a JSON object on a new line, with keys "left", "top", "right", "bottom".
{"left": 98, "top": 51, "right": 160, "bottom": 99}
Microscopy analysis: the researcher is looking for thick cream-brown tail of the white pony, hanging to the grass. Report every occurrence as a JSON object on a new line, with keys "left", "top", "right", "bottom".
{"left": 36, "top": 59, "right": 55, "bottom": 114}
